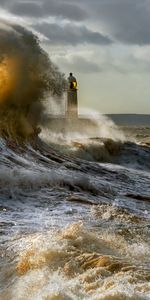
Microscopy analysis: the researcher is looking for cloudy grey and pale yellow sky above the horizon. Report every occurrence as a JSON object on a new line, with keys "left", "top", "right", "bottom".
{"left": 0, "top": 0, "right": 150, "bottom": 114}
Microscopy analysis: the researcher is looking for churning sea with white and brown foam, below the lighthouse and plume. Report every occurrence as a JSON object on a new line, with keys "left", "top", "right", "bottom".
{"left": 0, "top": 120, "right": 150, "bottom": 300}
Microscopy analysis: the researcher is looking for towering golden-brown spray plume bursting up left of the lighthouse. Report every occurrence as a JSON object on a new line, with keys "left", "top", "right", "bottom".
{"left": 0, "top": 22, "right": 66, "bottom": 138}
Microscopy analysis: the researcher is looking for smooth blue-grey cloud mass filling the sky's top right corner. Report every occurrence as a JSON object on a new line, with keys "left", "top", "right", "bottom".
{"left": 88, "top": 0, "right": 150, "bottom": 45}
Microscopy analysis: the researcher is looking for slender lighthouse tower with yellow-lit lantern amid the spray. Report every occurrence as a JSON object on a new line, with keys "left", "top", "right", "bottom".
{"left": 66, "top": 73, "right": 78, "bottom": 119}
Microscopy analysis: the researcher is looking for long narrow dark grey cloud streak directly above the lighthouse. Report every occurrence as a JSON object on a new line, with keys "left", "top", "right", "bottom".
{"left": 35, "top": 22, "right": 112, "bottom": 45}
